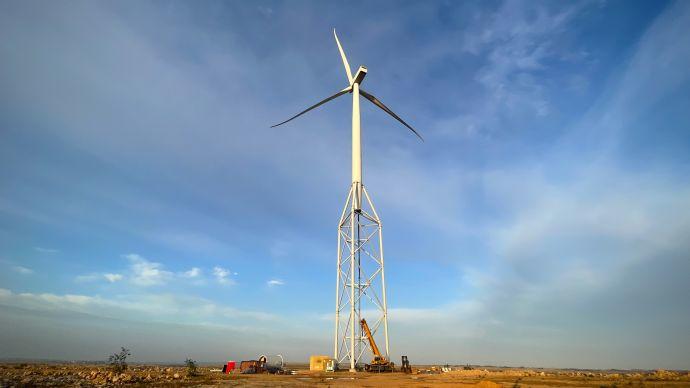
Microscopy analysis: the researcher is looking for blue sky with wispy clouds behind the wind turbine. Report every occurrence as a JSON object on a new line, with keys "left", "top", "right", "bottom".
{"left": 0, "top": 1, "right": 690, "bottom": 369}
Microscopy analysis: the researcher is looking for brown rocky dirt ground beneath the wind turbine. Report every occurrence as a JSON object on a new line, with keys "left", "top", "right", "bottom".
{"left": 0, "top": 363, "right": 690, "bottom": 388}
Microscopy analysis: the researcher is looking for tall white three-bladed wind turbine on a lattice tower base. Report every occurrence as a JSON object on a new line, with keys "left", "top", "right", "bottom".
{"left": 271, "top": 29, "right": 424, "bottom": 372}
